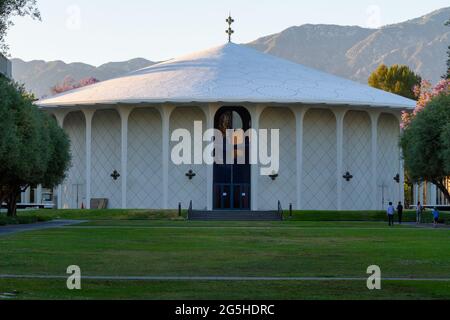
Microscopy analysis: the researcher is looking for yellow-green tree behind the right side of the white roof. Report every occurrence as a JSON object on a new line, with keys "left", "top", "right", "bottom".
{"left": 369, "top": 64, "right": 422, "bottom": 99}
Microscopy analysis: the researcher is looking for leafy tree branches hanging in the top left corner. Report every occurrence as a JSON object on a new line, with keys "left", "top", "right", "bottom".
{"left": 0, "top": 0, "right": 41, "bottom": 54}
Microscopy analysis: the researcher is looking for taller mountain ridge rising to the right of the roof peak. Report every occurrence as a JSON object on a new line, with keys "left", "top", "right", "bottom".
{"left": 249, "top": 7, "right": 450, "bottom": 83}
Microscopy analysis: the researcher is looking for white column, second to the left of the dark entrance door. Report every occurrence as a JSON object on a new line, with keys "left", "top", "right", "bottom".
{"left": 160, "top": 105, "right": 175, "bottom": 210}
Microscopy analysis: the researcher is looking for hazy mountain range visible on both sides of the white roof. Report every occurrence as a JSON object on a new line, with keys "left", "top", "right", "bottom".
{"left": 12, "top": 7, "right": 450, "bottom": 97}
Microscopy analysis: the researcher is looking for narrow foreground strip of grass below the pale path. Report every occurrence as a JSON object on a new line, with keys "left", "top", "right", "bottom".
{"left": 0, "top": 280, "right": 450, "bottom": 300}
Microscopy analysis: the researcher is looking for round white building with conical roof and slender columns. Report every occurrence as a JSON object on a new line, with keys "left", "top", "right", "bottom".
{"left": 37, "top": 43, "right": 415, "bottom": 210}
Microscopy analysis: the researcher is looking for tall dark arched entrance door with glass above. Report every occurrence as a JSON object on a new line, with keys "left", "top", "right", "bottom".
{"left": 213, "top": 107, "right": 251, "bottom": 210}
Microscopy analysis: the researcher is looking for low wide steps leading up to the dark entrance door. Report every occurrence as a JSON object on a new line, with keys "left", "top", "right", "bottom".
{"left": 189, "top": 210, "right": 283, "bottom": 221}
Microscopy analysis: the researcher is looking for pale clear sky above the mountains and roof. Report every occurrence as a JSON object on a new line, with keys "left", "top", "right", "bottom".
{"left": 7, "top": 0, "right": 449, "bottom": 66}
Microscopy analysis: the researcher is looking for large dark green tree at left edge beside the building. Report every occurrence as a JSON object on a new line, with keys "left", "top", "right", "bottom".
{"left": 0, "top": 77, "right": 70, "bottom": 216}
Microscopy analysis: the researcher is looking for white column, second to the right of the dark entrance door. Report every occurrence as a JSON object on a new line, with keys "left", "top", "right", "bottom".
{"left": 292, "top": 107, "right": 308, "bottom": 210}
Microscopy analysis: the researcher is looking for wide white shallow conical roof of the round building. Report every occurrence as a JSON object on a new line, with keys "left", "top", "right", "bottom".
{"left": 37, "top": 43, "right": 415, "bottom": 109}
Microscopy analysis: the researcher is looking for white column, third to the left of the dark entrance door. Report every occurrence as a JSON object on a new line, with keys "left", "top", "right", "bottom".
{"left": 117, "top": 106, "right": 134, "bottom": 209}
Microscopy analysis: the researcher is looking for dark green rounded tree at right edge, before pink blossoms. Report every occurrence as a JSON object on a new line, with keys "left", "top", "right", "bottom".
{"left": 401, "top": 92, "right": 450, "bottom": 201}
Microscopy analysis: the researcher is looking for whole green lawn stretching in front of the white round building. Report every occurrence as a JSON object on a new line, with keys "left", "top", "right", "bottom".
{"left": 0, "top": 210, "right": 450, "bottom": 299}
